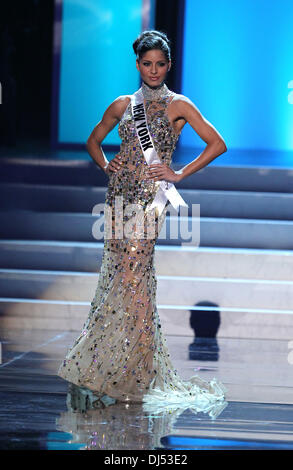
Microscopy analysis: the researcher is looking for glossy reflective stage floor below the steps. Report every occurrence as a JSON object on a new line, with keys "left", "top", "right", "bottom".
{"left": 0, "top": 330, "right": 293, "bottom": 450}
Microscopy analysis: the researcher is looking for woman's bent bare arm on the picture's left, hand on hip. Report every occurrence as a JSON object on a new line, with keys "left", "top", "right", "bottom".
{"left": 86, "top": 95, "right": 130, "bottom": 175}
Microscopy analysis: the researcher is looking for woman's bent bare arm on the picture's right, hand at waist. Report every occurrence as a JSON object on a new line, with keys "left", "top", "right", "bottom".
{"left": 149, "top": 95, "right": 227, "bottom": 183}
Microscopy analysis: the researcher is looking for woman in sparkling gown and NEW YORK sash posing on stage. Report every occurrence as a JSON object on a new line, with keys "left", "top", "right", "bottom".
{"left": 58, "top": 31, "right": 226, "bottom": 410}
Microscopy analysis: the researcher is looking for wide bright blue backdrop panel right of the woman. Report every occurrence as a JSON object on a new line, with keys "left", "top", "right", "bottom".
{"left": 181, "top": 0, "right": 293, "bottom": 150}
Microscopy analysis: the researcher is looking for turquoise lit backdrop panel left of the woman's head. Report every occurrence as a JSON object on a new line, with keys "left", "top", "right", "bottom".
{"left": 57, "top": 0, "right": 143, "bottom": 145}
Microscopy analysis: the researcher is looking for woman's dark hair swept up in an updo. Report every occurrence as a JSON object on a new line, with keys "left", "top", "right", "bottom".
{"left": 132, "top": 30, "right": 171, "bottom": 61}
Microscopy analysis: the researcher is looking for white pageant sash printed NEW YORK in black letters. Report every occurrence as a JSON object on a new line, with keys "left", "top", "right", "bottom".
{"left": 131, "top": 89, "right": 188, "bottom": 215}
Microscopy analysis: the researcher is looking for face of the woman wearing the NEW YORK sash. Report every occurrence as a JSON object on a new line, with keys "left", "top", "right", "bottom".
{"left": 136, "top": 49, "right": 171, "bottom": 87}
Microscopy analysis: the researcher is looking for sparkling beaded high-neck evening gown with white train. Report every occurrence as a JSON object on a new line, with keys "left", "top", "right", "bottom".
{"left": 57, "top": 82, "right": 226, "bottom": 412}
